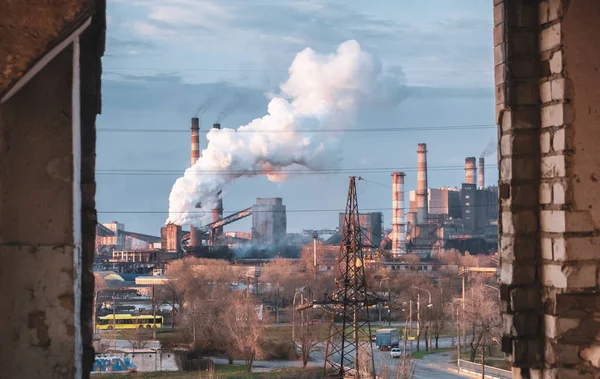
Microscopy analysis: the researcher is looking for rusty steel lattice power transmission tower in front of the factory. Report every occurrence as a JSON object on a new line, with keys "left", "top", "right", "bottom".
{"left": 324, "top": 176, "right": 385, "bottom": 378}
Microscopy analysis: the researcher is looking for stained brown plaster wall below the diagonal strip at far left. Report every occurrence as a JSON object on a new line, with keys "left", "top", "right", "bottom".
{"left": 0, "top": 49, "right": 79, "bottom": 378}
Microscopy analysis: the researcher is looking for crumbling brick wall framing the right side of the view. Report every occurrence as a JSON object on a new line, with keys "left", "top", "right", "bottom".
{"left": 494, "top": 0, "right": 600, "bottom": 378}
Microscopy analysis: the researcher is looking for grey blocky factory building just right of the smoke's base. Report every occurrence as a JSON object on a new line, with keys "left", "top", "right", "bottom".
{"left": 252, "top": 197, "right": 287, "bottom": 246}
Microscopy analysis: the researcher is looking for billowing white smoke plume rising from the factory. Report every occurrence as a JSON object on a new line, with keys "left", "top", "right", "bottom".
{"left": 167, "top": 40, "right": 404, "bottom": 225}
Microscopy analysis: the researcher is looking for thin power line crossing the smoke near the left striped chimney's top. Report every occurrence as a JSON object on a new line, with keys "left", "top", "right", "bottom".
{"left": 96, "top": 124, "right": 497, "bottom": 133}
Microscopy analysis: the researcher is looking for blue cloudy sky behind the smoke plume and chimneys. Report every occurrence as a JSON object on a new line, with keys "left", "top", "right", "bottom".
{"left": 96, "top": 0, "right": 498, "bottom": 235}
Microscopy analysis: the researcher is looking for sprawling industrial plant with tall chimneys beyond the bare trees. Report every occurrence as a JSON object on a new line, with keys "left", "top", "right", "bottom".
{"left": 96, "top": 118, "right": 498, "bottom": 272}
